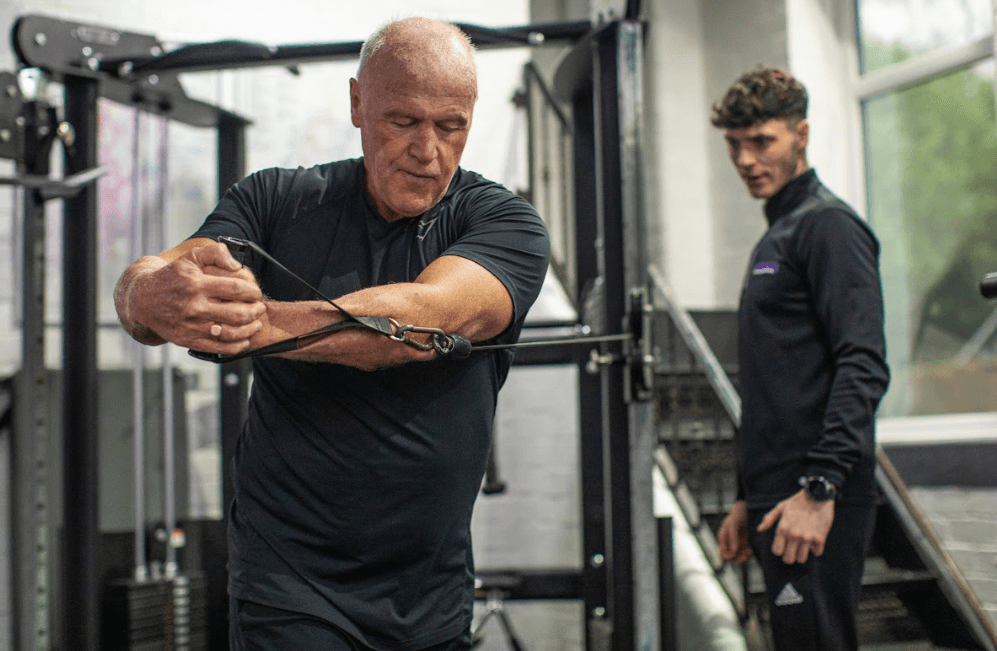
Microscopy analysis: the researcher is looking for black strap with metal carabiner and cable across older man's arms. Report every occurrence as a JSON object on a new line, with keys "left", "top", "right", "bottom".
{"left": 187, "top": 235, "right": 633, "bottom": 364}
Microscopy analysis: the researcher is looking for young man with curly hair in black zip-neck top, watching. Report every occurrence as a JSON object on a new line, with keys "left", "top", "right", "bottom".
{"left": 712, "top": 68, "right": 889, "bottom": 651}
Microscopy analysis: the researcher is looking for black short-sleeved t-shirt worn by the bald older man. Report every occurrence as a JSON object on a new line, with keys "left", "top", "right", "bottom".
{"left": 195, "top": 159, "right": 550, "bottom": 649}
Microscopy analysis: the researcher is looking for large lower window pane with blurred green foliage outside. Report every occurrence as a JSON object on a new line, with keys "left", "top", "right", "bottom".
{"left": 864, "top": 61, "right": 997, "bottom": 416}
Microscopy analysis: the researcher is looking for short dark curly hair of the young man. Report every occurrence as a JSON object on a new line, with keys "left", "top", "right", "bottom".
{"left": 710, "top": 66, "right": 807, "bottom": 129}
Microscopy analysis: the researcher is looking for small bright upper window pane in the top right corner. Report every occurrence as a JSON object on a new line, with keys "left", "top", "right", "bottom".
{"left": 858, "top": 0, "right": 993, "bottom": 73}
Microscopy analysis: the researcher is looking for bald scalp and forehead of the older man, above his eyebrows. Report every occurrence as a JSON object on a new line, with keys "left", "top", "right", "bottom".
{"left": 357, "top": 18, "right": 478, "bottom": 99}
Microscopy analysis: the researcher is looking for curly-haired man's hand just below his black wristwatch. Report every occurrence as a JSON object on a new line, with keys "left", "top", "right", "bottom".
{"left": 758, "top": 490, "right": 834, "bottom": 565}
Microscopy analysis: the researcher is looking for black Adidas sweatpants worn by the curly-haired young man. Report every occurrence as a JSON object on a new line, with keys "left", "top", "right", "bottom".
{"left": 748, "top": 504, "right": 876, "bottom": 651}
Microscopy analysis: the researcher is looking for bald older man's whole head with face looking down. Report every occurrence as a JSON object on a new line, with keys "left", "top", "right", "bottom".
{"left": 350, "top": 18, "right": 478, "bottom": 222}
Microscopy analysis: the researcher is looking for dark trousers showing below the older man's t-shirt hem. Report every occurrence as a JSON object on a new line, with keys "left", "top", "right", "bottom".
{"left": 229, "top": 598, "right": 471, "bottom": 651}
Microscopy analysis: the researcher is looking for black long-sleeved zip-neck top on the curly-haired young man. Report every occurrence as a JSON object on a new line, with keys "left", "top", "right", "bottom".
{"left": 738, "top": 170, "right": 889, "bottom": 508}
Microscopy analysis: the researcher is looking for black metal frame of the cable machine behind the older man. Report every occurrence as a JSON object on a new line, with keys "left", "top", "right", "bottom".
{"left": 0, "top": 11, "right": 670, "bottom": 651}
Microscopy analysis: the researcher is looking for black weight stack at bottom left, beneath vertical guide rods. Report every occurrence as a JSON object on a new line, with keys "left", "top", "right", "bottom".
{"left": 102, "top": 575, "right": 208, "bottom": 651}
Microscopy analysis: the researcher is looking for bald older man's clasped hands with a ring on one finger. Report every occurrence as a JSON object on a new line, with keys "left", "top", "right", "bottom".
{"left": 115, "top": 240, "right": 266, "bottom": 355}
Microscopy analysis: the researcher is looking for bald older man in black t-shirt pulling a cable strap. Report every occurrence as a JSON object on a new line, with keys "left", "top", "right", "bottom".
{"left": 115, "top": 18, "right": 550, "bottom": 651}
